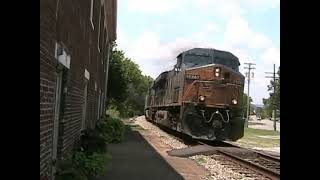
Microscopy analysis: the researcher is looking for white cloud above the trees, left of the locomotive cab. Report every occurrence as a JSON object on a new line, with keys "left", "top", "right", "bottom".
{"left": 118, "top": 31, "right": 198, "bottom": 78}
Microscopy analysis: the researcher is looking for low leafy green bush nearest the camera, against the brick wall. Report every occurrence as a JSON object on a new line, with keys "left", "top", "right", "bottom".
{"left": 73, "top": 151, "right": 111, "bottom": 177}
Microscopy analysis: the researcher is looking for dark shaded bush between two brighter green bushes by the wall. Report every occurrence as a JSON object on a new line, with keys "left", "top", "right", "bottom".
{"left": 78, "top": 129, "right": 107, "bottom": 155}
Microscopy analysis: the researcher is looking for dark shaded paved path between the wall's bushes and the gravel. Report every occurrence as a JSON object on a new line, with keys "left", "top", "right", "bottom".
{"left": 98, "top": 126, "right": 183, "bottom": 180}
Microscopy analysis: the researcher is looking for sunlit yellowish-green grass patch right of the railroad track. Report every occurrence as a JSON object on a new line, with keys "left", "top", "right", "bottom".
{"left": 237, "top": 128, "right": 280, "bottom": 148}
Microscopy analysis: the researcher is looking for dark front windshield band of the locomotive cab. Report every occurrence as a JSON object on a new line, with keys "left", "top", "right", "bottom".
{"left": 184, "top": 54, "right": 239, "bottom": 71}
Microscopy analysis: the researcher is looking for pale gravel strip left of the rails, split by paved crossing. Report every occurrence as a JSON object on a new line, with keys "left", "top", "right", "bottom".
{"left": 135, "top": 116, "right": 266, "bottom": 180}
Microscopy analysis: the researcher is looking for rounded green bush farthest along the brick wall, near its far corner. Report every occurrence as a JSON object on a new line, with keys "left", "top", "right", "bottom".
{"left": 96, "top": 116, "right": 125, "bottom": 143}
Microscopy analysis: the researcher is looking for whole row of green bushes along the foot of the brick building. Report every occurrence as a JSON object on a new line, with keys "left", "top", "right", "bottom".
{"left": 57, "top": 113, "right": 125, "bottom": 180}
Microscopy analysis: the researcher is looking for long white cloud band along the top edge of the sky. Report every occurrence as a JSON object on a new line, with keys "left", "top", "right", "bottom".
{"left": 127, "top": 0, "right": 280, "bottom": 18}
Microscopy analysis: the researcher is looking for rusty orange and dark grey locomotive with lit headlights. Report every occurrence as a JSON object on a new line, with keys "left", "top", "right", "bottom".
{"left": 145, "top": 48, "right": 245, "bottom": 141}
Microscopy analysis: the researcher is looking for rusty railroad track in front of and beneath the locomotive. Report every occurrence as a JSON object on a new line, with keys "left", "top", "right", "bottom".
{"left": 151, "top": 121, "right": 280, "bottom": 179}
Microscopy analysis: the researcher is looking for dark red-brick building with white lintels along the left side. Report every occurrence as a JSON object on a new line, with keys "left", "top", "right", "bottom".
{"left": 40, "top": 0, "right": 117, "bottom": 179}
